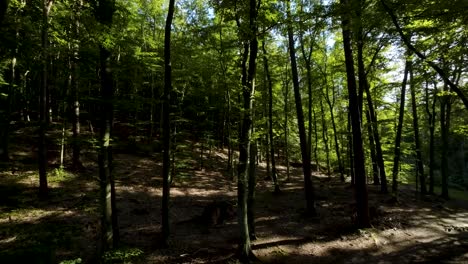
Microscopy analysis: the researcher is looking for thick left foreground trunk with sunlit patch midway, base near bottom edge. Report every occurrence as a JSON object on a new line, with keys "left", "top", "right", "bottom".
{"left": 96, "top": 0, "right": 119, "bottom": 251}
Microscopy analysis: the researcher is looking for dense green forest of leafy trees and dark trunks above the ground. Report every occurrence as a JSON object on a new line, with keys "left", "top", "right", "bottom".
{"left": 0, "top": 0, "right": 468, "bottom": 262}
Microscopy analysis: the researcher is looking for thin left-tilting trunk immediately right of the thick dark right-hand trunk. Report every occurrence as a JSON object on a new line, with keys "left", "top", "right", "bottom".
{"left": 365, "top": 80, "right": 388, "bottom": 193}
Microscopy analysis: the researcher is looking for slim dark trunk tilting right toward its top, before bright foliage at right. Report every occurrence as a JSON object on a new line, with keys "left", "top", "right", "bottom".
{"left": 392, "top": 60, "right": 411, "bottom": 198}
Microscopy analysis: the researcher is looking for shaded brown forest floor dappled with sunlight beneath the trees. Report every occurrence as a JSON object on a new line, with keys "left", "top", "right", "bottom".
{"left": 0, "top": 127, "right": 468, "bottom": 263}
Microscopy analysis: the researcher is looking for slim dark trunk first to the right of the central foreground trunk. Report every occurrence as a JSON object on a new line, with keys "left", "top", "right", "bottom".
{"left": 262, "top": 41, "right": 281, "bottom": 193}
